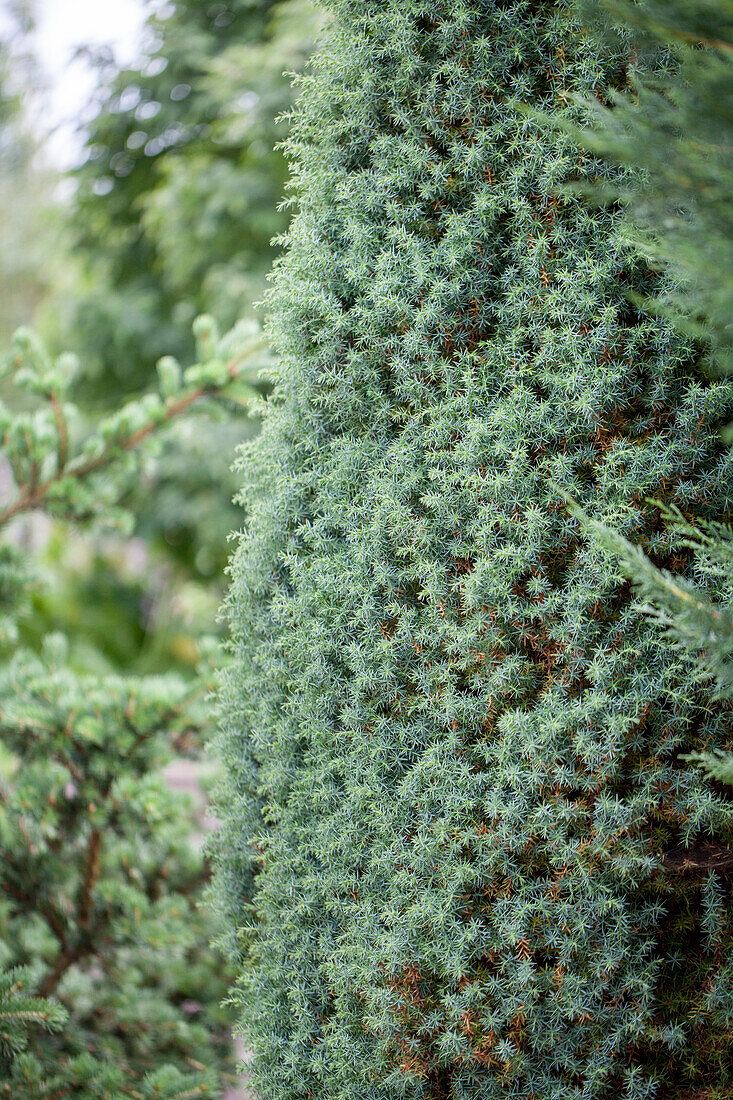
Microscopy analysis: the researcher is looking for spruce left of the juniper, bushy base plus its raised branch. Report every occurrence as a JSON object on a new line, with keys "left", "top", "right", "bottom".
{"left": 0, "top": 319, "right": 256, "bottom": 1100}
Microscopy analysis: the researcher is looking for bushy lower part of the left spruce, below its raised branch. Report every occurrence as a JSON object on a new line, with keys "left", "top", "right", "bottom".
{"left": 0, "top": 636, "right": 234, "bottom": 1100}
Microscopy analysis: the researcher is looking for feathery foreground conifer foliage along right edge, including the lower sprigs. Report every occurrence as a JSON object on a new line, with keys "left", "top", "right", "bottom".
{"left": 563, "top": 0, "right": 733, "bottom": 782}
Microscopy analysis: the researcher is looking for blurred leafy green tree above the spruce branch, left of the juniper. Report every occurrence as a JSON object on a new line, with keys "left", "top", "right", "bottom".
{"left": 58, "top": 0, "right": 320, "bottom": 403}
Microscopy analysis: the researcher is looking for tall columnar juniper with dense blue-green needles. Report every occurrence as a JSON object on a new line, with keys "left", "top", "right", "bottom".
{"left": 219, "top": 0, "right": 733, "bottom": 1100}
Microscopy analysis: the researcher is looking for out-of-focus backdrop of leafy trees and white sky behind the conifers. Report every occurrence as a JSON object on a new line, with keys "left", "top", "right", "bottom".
{"left": 0, "top": 0, "right": 319, "bottom": 1086}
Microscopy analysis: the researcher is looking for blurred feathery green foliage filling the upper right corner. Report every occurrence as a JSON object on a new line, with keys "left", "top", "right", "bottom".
{"left": 582, "top": 0, "right": 733, "bottom": 370}
